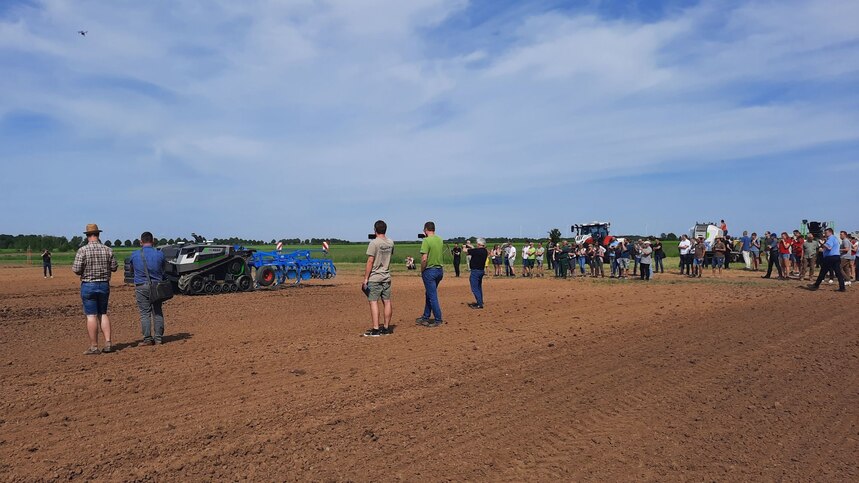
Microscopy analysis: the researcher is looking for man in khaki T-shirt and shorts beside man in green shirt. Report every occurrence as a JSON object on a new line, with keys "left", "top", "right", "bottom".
{"left": 363, "top": 220, "right": 394, "bottom": 337}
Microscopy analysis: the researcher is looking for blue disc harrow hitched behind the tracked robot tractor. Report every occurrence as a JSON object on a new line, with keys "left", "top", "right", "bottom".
{"left": 248, "top": 250, "right": 337, "bottom": 287}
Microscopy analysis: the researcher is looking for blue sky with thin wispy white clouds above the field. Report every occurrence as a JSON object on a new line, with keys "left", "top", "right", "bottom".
{"left": 0, "top": 0, "right": 859, "bottom": 240}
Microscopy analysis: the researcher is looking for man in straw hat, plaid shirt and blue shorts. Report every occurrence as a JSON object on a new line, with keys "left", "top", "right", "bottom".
{"left": 72, "top": 223, "right": 119, "bottom": 355}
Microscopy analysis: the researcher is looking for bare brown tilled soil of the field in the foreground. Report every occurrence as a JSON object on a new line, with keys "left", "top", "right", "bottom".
{"left": 0, "top": 267, "right": 859, "bottom": 481}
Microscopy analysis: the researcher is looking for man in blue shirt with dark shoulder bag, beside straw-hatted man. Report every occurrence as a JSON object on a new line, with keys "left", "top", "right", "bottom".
{"left": 129, "top": 231, "right": 167, "bottom": 347}
